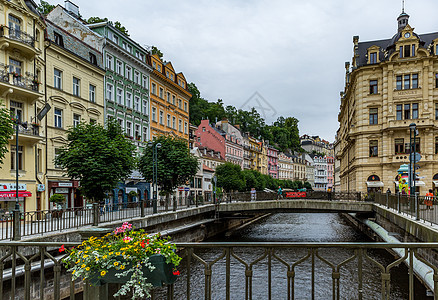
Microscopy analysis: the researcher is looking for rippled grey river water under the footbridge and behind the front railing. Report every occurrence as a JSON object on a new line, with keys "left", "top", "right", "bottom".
{"left": 166, "top": 213, "right": 432, "bottom": 300}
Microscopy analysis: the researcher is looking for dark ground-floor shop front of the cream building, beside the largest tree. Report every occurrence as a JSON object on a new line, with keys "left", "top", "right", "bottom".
{"left": 48, "top": 180, "right": 84, "bottom": 208}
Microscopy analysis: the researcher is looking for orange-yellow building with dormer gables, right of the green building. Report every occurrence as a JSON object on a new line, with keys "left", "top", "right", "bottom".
{"left": 149, "top": 54, "right": 192, "bottom": 142}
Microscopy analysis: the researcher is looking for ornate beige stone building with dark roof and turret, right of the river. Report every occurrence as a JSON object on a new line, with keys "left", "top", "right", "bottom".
{"left": 336, "top": 11, "right": 438, "bottom": 195}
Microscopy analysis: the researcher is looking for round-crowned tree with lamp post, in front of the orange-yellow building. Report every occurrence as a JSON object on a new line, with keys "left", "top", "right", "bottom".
{"left": 138, "top": 135, "right": 198, "bottom": 203}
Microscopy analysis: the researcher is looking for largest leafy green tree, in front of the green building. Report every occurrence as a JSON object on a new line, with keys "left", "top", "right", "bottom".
{"left": 55, "top": 120, "right": 136, "bottom": 202}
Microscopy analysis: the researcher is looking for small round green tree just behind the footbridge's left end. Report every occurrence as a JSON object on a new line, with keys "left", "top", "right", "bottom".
{"left": 216, "top": 162, "right": 245, "bottom": 192}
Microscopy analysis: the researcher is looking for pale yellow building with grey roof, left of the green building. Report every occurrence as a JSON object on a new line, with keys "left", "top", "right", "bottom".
{"left": 46, "top": 6, "right": 105, "bottom": 207}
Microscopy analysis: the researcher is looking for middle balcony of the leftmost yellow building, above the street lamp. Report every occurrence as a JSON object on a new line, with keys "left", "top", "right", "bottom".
{"left": 0, "top": 72, "right": 42, "bottom": 102}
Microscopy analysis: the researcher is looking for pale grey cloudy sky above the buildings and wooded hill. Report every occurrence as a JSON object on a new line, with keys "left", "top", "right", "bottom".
{"left": 45, "top": 0, "right": 438, "bottom": 141}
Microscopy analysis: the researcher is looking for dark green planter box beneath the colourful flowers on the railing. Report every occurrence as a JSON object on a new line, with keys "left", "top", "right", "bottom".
{"left": 89, "top": 254, "right": 178, "bottom": 287}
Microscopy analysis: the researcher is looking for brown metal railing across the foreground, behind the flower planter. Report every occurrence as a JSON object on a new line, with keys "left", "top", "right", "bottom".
{"left": 0, "top": 242, "right": 438, "bottom": 300}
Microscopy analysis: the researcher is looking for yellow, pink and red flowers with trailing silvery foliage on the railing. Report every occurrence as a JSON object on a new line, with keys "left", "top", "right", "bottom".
{"left": 59, "top": 222, "right": 181, "bottom": 299}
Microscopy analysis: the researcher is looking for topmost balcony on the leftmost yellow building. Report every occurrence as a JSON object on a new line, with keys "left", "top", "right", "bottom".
{"left": 0, "top": 26, "right": 41, "bottom": 58}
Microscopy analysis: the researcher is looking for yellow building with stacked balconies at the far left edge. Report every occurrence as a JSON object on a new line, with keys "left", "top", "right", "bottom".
{"left": 0, "top": 0, "right": 45, "bottom": 211}
